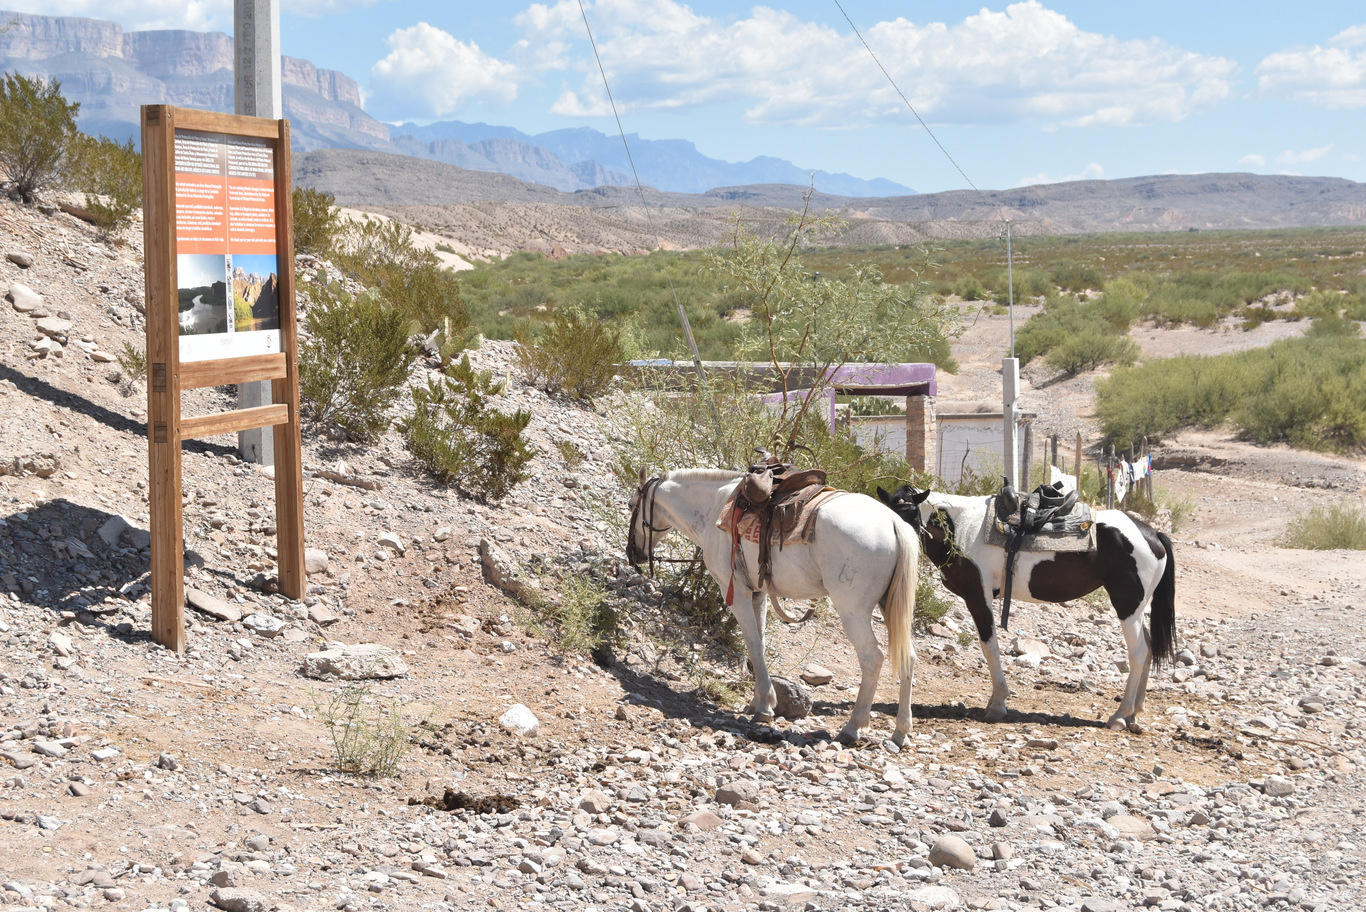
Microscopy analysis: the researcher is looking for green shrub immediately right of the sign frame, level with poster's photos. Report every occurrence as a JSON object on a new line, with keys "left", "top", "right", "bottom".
{"left": 299, "top": 274, "right": 417, "bottom": 442}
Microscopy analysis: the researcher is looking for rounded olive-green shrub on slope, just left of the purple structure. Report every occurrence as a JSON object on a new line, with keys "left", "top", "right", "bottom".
{"left": 516, "top": 310, "right": 626, "bottom": 399}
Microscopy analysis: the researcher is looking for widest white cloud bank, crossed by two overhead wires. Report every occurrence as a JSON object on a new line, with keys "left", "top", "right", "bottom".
{"left": 515, "top": 0, "right": 1235, "bottom": 127}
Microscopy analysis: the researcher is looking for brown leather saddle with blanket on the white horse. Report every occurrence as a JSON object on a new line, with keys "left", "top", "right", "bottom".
{"left": 716, "top": 456, "right": 844, "bottom": 623}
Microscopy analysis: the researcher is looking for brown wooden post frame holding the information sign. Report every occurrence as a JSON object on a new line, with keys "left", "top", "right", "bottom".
{"left": 142, "top": 105, "right": 305, "bottom": 653}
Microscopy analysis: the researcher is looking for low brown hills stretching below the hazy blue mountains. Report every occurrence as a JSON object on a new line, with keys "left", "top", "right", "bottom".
{"left": 294, "top": 149, "right": 1366, "bottom": 253}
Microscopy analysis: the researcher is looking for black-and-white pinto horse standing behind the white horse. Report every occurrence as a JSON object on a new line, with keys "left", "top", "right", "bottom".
{"left": 877, "top": 485, "right": 1176, "bottom": 732}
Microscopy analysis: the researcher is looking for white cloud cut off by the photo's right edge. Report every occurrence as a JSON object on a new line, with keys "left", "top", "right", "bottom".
{"left": 1257, "top": 26, "right": 1366, "bottom": 109}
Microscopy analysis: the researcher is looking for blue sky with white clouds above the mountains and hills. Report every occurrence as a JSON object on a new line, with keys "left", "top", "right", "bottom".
{"left": 13, "top": 0, "right": 1366, "bottom": 191}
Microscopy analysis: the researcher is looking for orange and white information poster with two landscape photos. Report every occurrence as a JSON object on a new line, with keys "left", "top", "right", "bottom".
{"left": 175, "top": 130, "right": 280, "bottom": 360}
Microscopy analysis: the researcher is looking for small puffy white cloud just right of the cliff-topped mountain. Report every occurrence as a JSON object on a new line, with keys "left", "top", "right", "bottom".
{"left": 367, "top": 22, "right": 520, "bottom": 117}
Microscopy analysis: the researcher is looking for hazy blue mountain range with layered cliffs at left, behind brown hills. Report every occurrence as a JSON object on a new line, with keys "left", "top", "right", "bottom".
{"left": 0, "top": 11, "right": 914, "bottom": 197}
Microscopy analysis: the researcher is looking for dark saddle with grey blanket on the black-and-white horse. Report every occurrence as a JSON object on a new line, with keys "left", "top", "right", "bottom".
{"left": 986, "top": 479, "right": 1096, "bottom": 629}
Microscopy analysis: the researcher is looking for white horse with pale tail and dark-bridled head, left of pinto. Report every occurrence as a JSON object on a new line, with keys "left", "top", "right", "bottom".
{"left": 627, "top": 468, "right": 919, "bottom": 744}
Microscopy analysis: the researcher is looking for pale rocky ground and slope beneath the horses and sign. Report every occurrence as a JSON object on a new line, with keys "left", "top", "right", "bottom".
{"left": 0, "top": 193, "right": 1366, "bottom": 912}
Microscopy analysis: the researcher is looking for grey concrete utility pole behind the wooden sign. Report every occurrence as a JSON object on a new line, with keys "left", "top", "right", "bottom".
{"left": 232, "top": 0, "right": 282, "bottom": 466}
